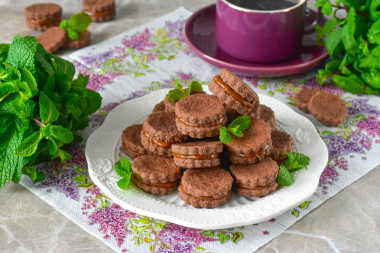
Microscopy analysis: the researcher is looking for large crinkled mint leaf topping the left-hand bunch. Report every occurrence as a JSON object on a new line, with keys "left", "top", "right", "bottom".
{"left": 6, "top": 35, "right": 37, "bottom": 74}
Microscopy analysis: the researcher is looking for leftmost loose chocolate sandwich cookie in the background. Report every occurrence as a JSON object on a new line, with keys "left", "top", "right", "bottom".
{"left": 24, "top": 3, "right": 62, "bottom": 31}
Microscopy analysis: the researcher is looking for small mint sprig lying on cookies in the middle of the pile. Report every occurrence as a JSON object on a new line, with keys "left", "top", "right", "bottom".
{"left": 219, "top": 116, "right": 251, "bottom": 144}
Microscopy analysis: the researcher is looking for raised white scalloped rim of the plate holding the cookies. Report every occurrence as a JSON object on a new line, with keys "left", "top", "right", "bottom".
{"left": 85, "top": 89, "right": 328, "bottom": 229}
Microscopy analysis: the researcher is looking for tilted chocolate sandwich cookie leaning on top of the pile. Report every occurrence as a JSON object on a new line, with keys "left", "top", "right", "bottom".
{"left": 208, "top": 69, "right": 259, "bottom": 115}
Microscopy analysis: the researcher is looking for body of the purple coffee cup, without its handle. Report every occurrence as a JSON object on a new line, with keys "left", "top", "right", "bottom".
{"left": 216, "top": 0, "right": 307, "bottom": 63}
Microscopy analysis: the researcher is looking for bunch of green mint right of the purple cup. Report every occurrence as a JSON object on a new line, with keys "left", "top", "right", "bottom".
{"left": 316, "top": 0, "right": 380, "bottom": 94}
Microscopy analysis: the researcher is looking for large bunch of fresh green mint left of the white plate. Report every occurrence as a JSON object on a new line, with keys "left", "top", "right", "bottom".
{"left": 0, "top": 36, "right": 101, "bottom": 188}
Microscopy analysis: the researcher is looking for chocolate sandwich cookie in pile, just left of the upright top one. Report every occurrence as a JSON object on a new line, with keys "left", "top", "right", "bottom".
{"left": 141, "top": 111, "right": 187, "bottom": 157}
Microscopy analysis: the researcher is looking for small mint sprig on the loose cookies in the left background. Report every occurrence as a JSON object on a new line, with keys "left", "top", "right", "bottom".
{"left": 59, "top": 13, "right": 91, "bottom": 40}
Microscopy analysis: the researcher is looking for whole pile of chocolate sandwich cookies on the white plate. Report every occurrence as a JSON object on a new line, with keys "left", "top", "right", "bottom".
{"left": 122, "top": 69, "right": 293, "bottom": 208}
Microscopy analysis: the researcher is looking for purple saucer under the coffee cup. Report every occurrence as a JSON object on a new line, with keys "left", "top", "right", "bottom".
{"left": 183, "top": 4, "right": 328, "bottom": 77}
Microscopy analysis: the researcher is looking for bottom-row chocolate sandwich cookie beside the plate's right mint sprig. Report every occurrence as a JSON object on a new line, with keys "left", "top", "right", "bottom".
{"left": 230, "top": 157, "right": 279, "bottom": 197}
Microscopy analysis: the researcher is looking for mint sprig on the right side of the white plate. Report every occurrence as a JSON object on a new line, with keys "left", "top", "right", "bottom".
{"left": 277, "top": 152, "right": 310, "bottom": 186}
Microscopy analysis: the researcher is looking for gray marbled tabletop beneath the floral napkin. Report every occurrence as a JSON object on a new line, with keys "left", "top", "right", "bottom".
{"left": 0, "top": 0, "right": 380, "bottom": 253}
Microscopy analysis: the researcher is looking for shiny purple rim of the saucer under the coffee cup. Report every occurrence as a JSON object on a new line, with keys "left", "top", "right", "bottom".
{"left": 182, "top": 4, "right": 329, "bottom": 77}
